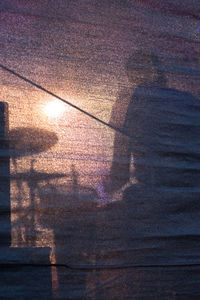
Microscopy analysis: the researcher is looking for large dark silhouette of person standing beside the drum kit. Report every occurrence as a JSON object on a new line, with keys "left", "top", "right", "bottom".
{"left": 95, "top": 52, "right": 200, "bottom": 299}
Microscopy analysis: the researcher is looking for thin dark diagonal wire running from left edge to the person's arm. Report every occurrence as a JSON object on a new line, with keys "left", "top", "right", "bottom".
{"left": 0, "top": 64, "right": 131, "bottom": 138}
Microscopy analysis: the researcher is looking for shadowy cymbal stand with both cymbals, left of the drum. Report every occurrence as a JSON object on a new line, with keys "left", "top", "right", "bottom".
{"left": 9, "top": 127, "right": 59, "bottom": 247}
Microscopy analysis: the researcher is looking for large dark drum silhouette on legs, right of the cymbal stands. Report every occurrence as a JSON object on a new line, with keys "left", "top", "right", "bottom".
{"left": 39, "top": 164, "right": 97, "bottom": 297}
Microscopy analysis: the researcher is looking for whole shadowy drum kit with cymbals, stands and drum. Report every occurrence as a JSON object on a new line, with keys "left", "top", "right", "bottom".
{"left": 7, "top": 128, "right": 97, "bottom": 295}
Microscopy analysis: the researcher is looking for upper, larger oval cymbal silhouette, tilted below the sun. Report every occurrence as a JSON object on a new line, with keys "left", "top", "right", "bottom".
{"left": 9, "top": 127, "right": 58, "bottom": 157}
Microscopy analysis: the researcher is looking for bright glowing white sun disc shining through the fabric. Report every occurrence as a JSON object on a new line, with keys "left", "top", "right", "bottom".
{"left": 44, "top": 100, "right": 66, "bottom": 118}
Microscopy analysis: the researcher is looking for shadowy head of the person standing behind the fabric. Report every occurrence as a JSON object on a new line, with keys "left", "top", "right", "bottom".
{"left": 126, "top": 50, "right": 165, "bottom": 85}
